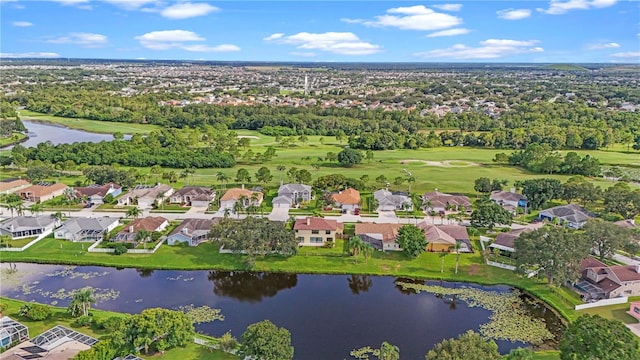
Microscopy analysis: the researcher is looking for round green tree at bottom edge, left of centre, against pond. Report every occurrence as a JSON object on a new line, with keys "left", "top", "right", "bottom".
{"left": 240, "top": 320, "right": 293, "bottom": 360}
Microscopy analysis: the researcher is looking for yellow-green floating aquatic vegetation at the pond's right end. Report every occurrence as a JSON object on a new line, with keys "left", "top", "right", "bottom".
{"left": 398, "top": 282, "right": 554, "bottom": 344}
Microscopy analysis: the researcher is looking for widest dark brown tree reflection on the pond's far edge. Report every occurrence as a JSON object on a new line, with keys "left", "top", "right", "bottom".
{"left": 207, "top": 270, "right": 298, "bottom": 302}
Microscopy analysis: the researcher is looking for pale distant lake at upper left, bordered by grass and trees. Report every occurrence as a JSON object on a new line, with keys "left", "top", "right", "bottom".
{"left": 5, "top": 120, "right": 131, "bottom": 149}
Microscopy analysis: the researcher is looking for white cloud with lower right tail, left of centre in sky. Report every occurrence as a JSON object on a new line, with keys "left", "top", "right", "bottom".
{"left": 134, "top": 30, "right": 240, "bottom": 52}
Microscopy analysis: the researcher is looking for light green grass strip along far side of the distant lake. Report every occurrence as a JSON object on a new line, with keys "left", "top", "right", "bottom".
{"left": 20, "top": 110, "right": 160, "bottom": 134}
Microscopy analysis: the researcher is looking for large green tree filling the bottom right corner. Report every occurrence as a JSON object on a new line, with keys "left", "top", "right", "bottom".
{"left": 560, "top": 314, "right": 640, "bottom": 360}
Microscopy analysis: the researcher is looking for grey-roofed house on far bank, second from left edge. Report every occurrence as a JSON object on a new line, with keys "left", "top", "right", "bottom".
{"left": 53, "top": 216, "right": 120, "bottom": 242}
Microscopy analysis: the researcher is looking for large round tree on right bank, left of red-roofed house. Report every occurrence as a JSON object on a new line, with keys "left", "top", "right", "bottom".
{"left": 514, "top": 226, "right": 591, "bottom": 285}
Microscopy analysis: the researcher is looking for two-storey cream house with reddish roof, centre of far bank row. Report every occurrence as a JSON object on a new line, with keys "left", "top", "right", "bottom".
{"left": 293, "top": 217, "right": 344, "bottom": 246}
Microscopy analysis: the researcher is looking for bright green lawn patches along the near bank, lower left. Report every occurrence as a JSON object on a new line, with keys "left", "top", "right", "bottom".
{"left": 0, "top": 297, "right": 238, "bottom": 360}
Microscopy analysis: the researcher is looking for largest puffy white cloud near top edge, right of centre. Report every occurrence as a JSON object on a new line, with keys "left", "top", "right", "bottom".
{"left": 343, "top": 5, "right": 462, "bottom": 31}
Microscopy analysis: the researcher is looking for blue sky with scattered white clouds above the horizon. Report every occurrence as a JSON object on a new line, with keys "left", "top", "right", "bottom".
{"left": 0, "top": 0, "right": 640, "bottom": 63}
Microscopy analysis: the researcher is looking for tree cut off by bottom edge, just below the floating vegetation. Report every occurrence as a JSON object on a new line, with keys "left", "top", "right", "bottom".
{"left": 425, "top": 330, "right": 500, "bottom": 360}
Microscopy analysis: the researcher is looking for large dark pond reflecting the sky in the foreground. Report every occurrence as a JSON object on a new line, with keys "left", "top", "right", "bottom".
{"left": 0, "top": 263, "right": 562, "bottom": 359}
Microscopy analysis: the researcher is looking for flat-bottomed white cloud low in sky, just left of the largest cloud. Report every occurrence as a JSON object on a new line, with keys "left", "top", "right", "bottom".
{"left": 265, "top": 32, "right": 381, "bottom": 55}
